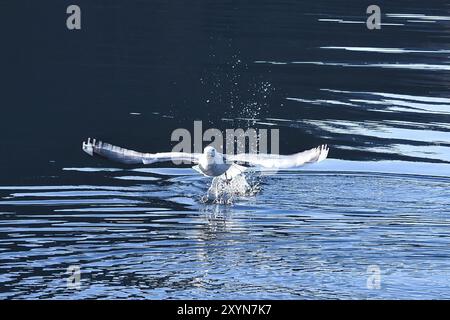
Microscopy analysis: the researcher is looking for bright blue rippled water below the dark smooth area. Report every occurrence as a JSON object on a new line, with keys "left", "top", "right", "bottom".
{"left": 0, "top": 168, "right": 450, "bottom": 299}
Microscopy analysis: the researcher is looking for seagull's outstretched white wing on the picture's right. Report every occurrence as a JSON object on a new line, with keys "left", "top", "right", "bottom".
{"left": 226, "top": 145, "right": 329, "bottom": 169}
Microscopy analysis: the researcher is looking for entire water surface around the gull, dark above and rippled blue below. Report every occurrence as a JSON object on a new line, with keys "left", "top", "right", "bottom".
{"left": 0, "top": 0, "right": 450, "bottom": 299}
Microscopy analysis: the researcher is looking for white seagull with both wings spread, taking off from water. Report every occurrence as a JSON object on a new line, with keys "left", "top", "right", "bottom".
{"left": 82, "top": 138, "right": 329, "bottom": 180}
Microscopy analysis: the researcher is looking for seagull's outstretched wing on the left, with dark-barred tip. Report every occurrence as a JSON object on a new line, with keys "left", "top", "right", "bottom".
{"left": 83, "top": 138, "right": 200, "bottom": 164}
